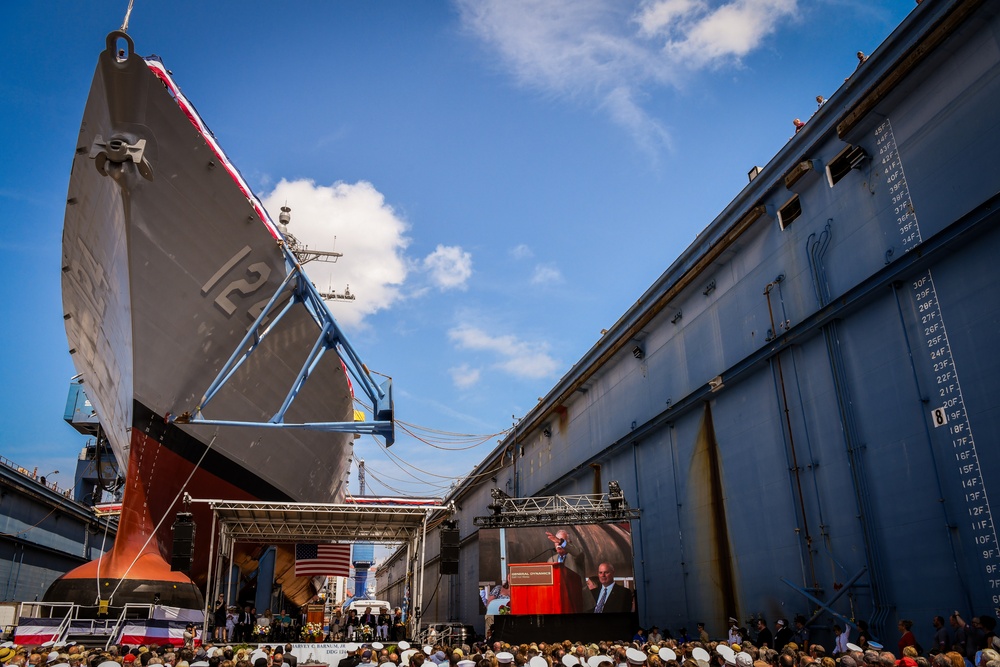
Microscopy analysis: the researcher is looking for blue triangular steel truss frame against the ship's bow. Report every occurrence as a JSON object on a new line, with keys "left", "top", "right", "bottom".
{"left": 170, "top": 253, "right": 395, "bottom": 446}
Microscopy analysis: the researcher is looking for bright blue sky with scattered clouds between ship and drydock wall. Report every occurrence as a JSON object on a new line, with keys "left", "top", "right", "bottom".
{"left": 0, "top": 0, "right": 916, "bottom": 495}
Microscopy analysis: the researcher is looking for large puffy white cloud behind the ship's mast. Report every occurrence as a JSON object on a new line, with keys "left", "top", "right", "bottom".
{"left": 262, "top": 179, "right": 409, "bottom": 327}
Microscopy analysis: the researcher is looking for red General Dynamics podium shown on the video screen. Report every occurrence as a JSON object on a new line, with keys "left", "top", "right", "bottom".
{"left": 508, "top": 563, "right": 583, "bottom": 614}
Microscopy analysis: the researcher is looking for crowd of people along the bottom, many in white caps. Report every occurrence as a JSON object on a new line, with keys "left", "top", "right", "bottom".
{"left": 0, "top": 612, "right": 1000, "bottom": 667}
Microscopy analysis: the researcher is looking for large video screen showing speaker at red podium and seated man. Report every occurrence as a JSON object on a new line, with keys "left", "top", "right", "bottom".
{"left": 479, "top": 523, "right": 636, "bottom": 616}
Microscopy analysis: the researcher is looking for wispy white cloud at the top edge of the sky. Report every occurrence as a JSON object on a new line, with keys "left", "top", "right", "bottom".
{"left": 456, "top": 0, "right": 797, "bottom": 149}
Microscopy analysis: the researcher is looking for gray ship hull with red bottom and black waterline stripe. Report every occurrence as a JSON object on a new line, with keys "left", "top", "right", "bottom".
{"left": 56, "top": 34, "right": 354, "bottom": 606}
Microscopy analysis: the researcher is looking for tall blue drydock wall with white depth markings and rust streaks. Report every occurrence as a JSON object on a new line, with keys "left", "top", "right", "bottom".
{"left": 380, "top": 1, "right": 1000, "bottom": 646}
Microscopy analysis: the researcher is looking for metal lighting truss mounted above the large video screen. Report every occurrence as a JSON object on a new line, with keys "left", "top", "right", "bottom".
{"left": 473, "top": 489, "right": 639, "bottom": 528}
